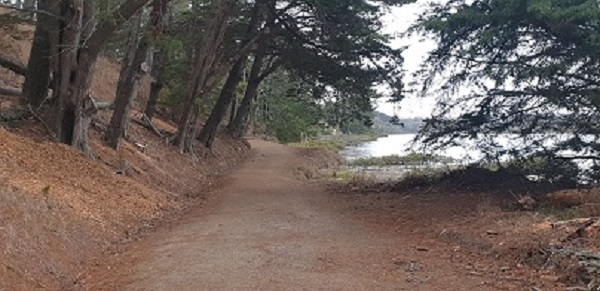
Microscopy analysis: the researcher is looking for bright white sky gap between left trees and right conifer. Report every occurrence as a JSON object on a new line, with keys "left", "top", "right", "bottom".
{"left": 377, "top": 0, "right": 435, "bottom": 118}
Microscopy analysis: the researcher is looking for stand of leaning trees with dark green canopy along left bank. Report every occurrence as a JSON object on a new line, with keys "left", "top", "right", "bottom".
{"left": 0, "top": 0, "right": 414, "bottom": 156}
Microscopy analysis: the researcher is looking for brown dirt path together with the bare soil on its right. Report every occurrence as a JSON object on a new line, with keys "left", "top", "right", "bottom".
{"left": 85, "top": 141, "right": 596, "bottom": 290}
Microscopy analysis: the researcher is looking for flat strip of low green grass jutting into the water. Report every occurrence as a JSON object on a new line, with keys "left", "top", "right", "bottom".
{"left": 350, "top": 153, "right": 455, "bottom": 167}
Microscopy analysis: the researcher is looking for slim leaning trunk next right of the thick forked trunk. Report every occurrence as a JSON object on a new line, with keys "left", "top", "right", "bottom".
{"left": 105, "top": 13, "right": 149, "bottom": 149}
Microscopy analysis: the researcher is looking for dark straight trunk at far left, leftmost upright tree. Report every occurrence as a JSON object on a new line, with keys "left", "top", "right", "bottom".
{"left": 23, "top": 0, "right": 52, "bottom": 108}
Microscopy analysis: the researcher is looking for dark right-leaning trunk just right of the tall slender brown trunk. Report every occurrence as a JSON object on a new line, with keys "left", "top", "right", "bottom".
{"left": 194, "top": 57, "right": 247, "bottom": 149}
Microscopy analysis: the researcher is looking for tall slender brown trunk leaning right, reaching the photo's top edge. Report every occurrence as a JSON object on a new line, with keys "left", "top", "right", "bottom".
{"left": 177, "top": 0, "right": 232, "bottom": 152}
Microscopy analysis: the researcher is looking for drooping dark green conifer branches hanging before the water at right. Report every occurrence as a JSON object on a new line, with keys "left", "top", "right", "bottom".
{"left": 413, "top": 0, "right": 600, "bottom": 180}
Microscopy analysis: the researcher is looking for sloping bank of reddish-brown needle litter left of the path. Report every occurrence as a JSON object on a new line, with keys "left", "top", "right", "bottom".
{"left": 0, "top": 15, "right": 250, "bottom": 290}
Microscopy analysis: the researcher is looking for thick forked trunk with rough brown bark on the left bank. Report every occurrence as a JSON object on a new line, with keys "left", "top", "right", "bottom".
{"left": 36, "top": 0, "right": 148, "bottom": 155}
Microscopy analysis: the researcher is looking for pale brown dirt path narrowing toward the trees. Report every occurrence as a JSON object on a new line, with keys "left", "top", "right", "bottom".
{"left": 86, "top": 141, "right": 524, "bottom": 291}
